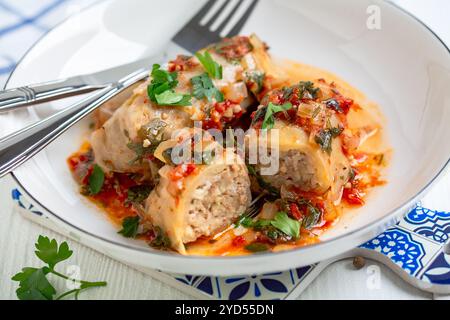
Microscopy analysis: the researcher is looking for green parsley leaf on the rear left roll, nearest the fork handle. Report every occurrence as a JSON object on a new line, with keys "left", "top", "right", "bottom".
{"left": 147, "top": 64, "right": 191, "bottom": 106}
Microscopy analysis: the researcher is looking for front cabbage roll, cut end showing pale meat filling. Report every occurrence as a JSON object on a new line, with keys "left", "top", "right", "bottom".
{"left": 146, "top": 129, "right": 251, "bottom": 254}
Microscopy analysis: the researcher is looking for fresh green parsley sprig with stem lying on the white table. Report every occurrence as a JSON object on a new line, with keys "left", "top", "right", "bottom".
{"left": 11, "top": 235, "right": 107, "bottom": 300}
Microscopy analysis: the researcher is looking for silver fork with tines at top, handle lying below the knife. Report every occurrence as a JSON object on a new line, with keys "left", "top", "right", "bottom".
{"left": 0, "top": 0, "right": 258, "bottom": 178}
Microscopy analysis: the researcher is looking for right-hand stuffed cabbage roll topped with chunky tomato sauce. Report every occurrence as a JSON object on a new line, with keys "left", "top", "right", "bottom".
{"left": 248, "top": 82, "right": 352, "bottom": 203}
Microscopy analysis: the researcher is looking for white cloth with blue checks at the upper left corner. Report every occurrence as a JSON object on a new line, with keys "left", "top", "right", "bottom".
{"left": 0, "top": 0, "right": 97, "bottom": 88}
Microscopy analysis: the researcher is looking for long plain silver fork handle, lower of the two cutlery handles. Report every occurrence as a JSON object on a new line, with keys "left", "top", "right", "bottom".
{"left": 0, "top": 70, "right": 148, "bottom": 178}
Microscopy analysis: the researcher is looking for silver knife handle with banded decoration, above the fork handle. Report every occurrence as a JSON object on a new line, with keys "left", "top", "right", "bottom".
{"left": 0, "top": 79, "right": 105, "bottom": 113}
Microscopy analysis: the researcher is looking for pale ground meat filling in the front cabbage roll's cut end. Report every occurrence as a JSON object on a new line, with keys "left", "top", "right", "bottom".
{"left": 183, "top": 165, "right": 251, "bottom": 243}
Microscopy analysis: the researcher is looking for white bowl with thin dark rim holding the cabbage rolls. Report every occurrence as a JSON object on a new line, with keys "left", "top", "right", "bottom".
{"left": 0, "top": 0, "right": 450, "bottom": 275}
